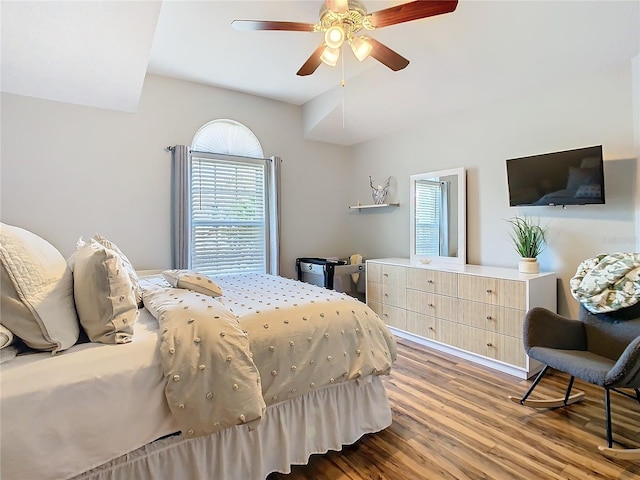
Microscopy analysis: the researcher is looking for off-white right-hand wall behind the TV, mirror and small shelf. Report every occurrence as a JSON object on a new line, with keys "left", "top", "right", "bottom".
{"left": 350, "top": 65, "right": 637, "bottom": 314}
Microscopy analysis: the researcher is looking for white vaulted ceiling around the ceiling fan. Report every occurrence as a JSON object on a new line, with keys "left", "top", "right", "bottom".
{"left": 0, "top": 0, "right": 640, "bottom": 145}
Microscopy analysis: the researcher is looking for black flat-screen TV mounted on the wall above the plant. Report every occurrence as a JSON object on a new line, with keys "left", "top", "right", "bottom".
{"left": 507, "top": 145, "right": 604, "bottom": 207}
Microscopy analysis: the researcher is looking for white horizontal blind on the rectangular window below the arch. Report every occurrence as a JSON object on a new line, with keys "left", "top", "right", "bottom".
{"left": 191, "top": 155, "right": 269, "bottom": 276}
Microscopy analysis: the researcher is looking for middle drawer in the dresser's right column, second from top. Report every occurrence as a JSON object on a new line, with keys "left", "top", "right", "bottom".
{"left": 458, "top": 300, "right": 525, "bottom": 339}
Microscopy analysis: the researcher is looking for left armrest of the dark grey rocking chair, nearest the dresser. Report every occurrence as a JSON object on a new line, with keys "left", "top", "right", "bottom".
{"left": 523, "top": 307, "right": 587, "bottom": 353}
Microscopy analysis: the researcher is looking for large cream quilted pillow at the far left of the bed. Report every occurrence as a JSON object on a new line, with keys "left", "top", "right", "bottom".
{"left": 0, "top": 223, "right": 80, "bottom": 353}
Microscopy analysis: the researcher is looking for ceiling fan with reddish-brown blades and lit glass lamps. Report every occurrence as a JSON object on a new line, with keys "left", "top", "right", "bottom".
{"left": 231, "top": 0, "right": 458, "bottom": 76}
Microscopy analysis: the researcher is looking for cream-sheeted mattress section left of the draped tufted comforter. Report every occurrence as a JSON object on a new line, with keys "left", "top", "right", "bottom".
{"left": 0, "top": 308, "right": 178, "bottom": 480}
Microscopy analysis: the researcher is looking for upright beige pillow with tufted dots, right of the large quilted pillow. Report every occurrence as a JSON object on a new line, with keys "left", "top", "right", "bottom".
{"left": 69, "top": 239, "right": 138, "bottom": 344}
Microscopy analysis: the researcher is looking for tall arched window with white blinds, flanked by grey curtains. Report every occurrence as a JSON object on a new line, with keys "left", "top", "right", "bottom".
{"left": 174, "top": 119, "right": 280, "bottom": 276}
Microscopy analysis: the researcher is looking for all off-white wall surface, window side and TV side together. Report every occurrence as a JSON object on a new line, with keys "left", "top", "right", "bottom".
{"left": 0, "top": 65, "right": 640, "bottom": 314}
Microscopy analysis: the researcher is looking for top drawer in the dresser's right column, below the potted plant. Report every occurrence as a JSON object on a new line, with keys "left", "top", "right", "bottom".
{"left": 458, "top": 274, "right": 527, "bottom": 310}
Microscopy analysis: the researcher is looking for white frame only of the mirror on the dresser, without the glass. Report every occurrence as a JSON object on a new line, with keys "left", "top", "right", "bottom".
{"left": 409, "top": 167, "right": 467, "bottom": 265}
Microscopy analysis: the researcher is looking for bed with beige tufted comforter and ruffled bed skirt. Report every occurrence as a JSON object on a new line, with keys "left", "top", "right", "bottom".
{"left": 0, "top": 225, "right": 396, "bottom": 480}
